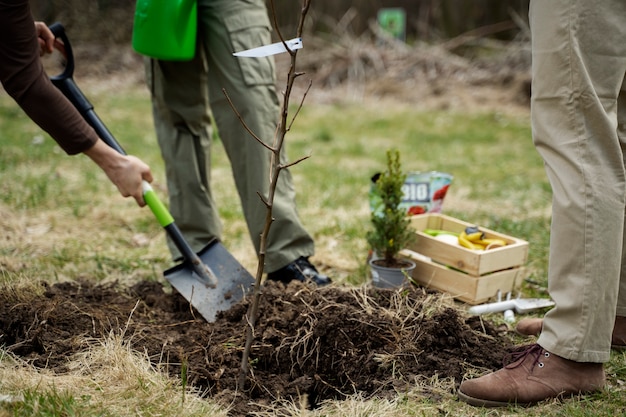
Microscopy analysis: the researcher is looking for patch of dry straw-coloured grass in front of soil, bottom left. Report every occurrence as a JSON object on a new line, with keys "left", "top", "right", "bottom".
{"left": 0, "top": 334, "right": 227, "bottom": 416}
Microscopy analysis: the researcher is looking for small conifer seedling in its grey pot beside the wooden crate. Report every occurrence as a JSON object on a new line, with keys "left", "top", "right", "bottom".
{"left": 366, "top": 150, "right": 415, "bottom": 287}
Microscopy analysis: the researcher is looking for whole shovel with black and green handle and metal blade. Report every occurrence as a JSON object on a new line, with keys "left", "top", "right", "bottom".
{"left": 50, "top": 23, "right": 255, "bottom": 322}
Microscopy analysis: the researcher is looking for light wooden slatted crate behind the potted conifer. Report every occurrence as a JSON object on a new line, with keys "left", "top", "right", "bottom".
{"left": 402, "top": 213, "right": 528, "bottom": 304}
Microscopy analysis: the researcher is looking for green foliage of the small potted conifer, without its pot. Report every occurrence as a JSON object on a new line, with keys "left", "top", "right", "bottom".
{"left": 366, "top": 149, "right": 413, "bottom": 267}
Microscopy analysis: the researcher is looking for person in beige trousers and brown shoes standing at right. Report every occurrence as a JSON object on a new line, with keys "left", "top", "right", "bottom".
{"left": 458, "top": 0, "right": 626, "bottom": 406}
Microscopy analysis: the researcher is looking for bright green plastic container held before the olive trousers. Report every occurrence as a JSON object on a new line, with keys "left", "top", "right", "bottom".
{"left": 132, "top": 0, "right": 198, "bottom": 61}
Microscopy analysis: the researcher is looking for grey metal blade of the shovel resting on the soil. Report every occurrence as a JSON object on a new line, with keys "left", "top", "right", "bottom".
{"left": 163, "top": 240, "right": 255, "bottom": 323}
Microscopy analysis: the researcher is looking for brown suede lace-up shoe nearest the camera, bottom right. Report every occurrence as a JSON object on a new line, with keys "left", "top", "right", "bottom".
{"left": 458, "top": 344, "right": 604, "bottom": 407}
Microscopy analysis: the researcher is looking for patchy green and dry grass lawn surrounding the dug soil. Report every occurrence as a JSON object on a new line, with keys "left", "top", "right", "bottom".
{"left": 0, "top": 83, "right": 626, "bottom": 417}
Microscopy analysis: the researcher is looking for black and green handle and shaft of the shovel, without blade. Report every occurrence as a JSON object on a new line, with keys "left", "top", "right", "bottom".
{"left": 50, "top": 23, "right": 217, "bottom": 288}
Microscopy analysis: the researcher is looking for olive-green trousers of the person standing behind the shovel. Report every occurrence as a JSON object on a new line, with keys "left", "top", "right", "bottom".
{"left": 146, "top": 0, "right": 314, "bottom": 272}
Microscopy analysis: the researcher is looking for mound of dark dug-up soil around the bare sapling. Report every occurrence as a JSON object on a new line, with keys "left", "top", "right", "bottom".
{"left": 0, "top": 282, "right": 510, "bottom": 415}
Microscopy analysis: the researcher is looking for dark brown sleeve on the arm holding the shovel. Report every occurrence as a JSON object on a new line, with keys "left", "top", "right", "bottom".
{"left": 0, "top": 0, "right": 98, "bottom": 155}
